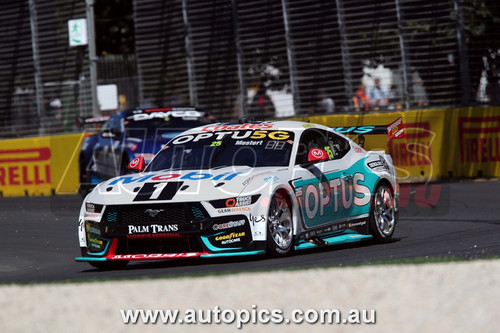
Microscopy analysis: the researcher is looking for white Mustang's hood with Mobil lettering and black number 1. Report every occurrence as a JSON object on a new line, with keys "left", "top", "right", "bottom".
{"left": 87, "top": 166, "right": 286, "bottom": 205}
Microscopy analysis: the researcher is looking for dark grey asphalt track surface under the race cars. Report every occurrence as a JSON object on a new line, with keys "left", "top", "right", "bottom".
{"left": 0, "top": 181, "right": 500, "bottom": 283}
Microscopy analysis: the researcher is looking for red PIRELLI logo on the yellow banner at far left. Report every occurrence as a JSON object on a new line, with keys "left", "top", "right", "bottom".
{"left": 0, "top": 147, "right": 51, "bottom": 186}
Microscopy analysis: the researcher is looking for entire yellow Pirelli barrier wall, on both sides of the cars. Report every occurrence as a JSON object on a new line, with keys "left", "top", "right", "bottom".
{"left": 0, "top": 107, "right": 500, "bottom": 196}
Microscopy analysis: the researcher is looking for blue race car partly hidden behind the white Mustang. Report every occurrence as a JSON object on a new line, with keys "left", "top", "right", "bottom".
{"left": 79, "top": 107, "right": 215, "bottom": 195}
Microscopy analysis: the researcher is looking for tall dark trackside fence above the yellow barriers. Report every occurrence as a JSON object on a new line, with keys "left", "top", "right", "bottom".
{"left": 0, "top": 0, "right": 500, "bottom": 137}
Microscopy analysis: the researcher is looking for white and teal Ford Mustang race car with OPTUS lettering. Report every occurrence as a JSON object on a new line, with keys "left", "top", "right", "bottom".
{"left": 76, "top": 121, "right": 398, "bottom": 268}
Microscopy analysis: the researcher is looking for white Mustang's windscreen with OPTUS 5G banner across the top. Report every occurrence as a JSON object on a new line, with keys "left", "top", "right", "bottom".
{"left": 146, "top": 130, "right": 294, "bottom": 171}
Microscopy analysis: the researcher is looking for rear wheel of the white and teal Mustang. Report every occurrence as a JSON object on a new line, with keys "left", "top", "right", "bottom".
{"left": 368, "top": 183, "right": 397, "bottom": 243}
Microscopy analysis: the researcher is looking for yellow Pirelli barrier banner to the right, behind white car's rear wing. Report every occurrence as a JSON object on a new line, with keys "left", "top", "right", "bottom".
{"left": 297, "top": 107, "right": 500, "bottom": 182}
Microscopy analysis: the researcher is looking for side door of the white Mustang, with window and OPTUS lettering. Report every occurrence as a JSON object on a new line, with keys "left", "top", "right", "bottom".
{"left": 293, "top": 128, "right": 354, "bottom": 230}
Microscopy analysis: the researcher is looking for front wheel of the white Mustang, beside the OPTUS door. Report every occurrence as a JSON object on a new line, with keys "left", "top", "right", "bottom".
{"left": 267, "top": 192, "right": 293, "bottom": 257}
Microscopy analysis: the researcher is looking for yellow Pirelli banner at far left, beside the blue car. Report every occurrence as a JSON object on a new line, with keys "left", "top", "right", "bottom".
{"left": 0, "top": 134, "right": 82, "bottom": 196}
